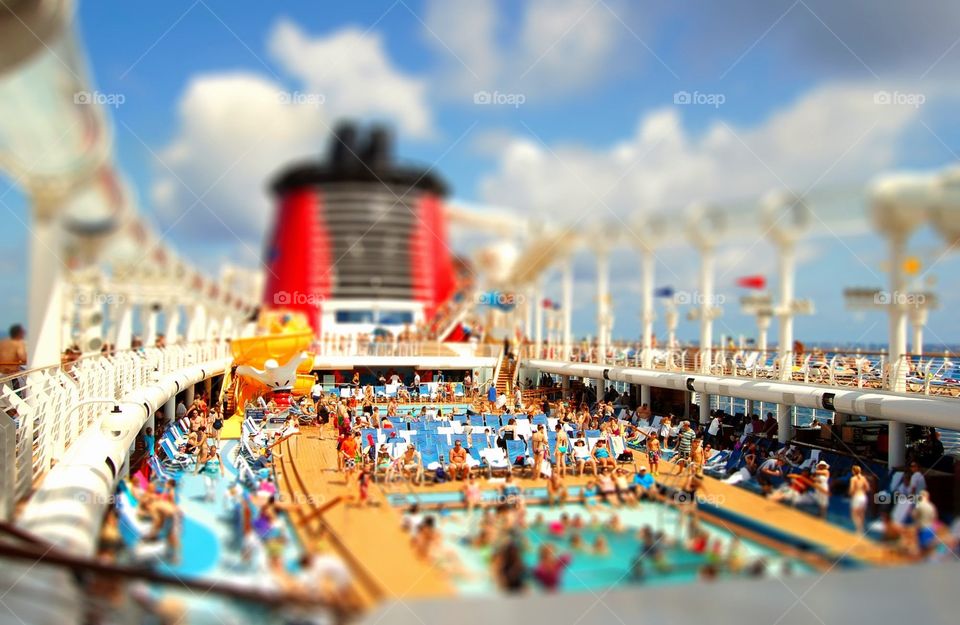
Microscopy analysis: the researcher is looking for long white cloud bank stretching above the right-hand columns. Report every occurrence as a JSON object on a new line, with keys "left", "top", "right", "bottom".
{"left": 480, "top": 85, "right": 917, "bottom": 224}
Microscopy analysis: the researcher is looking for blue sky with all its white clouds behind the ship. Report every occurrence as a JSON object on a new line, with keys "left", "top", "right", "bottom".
{"left": 0, "top": 0, "right": 960, "bottom": 345}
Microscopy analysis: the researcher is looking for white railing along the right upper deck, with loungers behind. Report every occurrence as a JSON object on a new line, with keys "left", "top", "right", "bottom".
{"left": 526, "top": 344, "right": 960, "bottom": 397}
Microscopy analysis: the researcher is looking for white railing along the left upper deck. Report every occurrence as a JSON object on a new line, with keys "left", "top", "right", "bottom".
{"left": 0, "top": 341, "right": 230, "bottom": 499}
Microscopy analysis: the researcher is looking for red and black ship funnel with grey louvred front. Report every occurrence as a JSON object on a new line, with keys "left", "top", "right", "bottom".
{"left": 264, "top": 124, "right": 455, "bottom": 334}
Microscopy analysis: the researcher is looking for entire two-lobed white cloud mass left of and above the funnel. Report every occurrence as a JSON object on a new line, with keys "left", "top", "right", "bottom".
{"left": 151, "top": 20, "right": 432, "bottom": 249}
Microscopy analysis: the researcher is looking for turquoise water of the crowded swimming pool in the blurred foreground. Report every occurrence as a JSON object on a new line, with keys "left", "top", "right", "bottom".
{"left": 428, "top": 503, "right": 813, "bottom": 595}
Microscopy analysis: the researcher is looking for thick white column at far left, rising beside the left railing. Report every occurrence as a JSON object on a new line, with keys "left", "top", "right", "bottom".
{"left": 25, "top": 215, "right": 63, "bottom": 369}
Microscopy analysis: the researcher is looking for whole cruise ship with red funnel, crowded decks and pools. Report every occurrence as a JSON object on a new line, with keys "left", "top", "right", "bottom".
{"left": 0, "top": 0, "right": 960, "bottom": 625}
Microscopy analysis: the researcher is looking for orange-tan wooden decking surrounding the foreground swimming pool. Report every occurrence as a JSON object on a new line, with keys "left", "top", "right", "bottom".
{"left": 278, "top": 427, "right": 905, "bottom": 605}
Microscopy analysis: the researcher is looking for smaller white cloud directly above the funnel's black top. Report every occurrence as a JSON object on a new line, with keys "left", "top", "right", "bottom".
{"left": 268, "top": 19, "right": 431, "bottom": 137}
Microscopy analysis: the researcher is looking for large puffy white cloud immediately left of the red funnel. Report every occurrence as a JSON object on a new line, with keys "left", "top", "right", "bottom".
{"left": 151, "top": 73, "right": 324, "bottom": 244}
